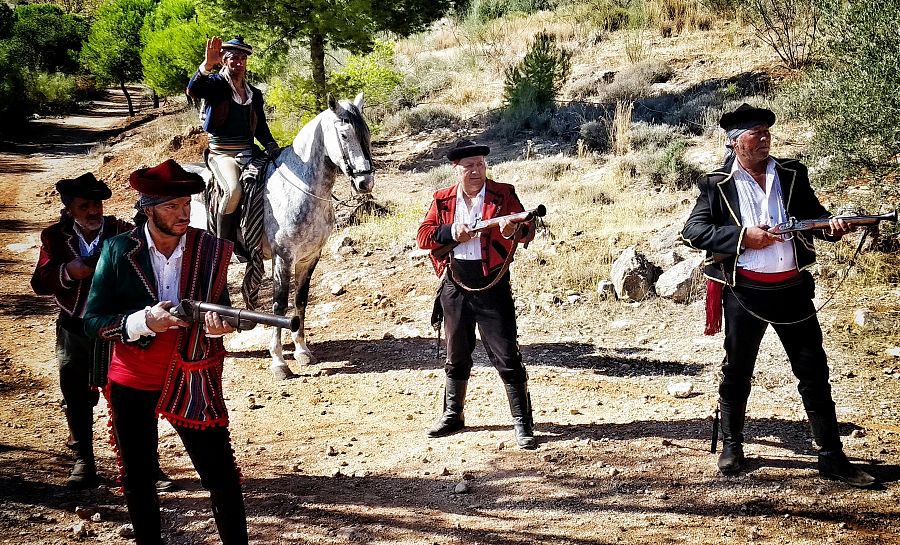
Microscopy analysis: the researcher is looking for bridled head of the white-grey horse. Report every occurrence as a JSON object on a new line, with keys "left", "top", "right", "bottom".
{"left": 322, "top": 93, "right": 375, "bottom": 193}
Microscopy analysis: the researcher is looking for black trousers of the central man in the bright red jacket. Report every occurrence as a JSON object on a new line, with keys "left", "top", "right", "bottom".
{"left": 440, "top": 260, "right": 528, "bottom": 384}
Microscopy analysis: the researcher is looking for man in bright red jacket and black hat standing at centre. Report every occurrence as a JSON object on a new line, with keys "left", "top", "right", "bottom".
{"left": 416, "top": 140, "right": 537, "bottom": 449}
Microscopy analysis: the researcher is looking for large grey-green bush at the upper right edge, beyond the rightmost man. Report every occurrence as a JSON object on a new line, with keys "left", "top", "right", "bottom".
{"left": 785, "top": 0, "right": 900, "bottom": 187}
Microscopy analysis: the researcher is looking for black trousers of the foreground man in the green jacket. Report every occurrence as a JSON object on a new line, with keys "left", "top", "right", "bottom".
{"left": 110, "top": 383, "right": 247, "bottom": 545}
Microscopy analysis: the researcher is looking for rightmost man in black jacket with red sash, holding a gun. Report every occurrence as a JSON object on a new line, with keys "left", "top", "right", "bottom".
{"left": 681, "top": 104, "right": 875, "bottom": 487}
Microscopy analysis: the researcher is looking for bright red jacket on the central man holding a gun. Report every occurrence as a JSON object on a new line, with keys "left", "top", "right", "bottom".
{"left": 416, "top": 180, "right": 534, "bottom": 276}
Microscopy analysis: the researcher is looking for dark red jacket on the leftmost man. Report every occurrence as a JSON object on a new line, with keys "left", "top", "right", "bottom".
{"left": 31, "top": 216, "right": 133, "bottom": 316}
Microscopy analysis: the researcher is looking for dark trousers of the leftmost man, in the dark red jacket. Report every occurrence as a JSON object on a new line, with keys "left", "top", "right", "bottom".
{"left": 56, "top": 313, "right": 100, "bottom": 459}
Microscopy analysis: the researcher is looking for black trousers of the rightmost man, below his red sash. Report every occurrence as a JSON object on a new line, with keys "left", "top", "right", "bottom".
{"left": 719, "top": 272, "right": 837, "bottom": 447}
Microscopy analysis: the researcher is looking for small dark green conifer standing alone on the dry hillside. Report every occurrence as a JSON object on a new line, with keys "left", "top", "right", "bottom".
{"left": 503, "top": 32, "right": 572, "bottom": 125}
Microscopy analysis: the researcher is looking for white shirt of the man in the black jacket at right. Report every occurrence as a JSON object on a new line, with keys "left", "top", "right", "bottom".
{"left": 731, "top": 157, "right": 797, "bottom": 273}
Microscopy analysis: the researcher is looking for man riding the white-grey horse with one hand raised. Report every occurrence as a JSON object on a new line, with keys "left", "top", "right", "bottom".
{"left": 187, "top": 36, "right": 279, "bottom": 258}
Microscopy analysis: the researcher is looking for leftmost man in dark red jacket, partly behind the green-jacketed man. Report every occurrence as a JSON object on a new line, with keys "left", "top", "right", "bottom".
{"left": 31, "top": 173, "right": 131, "bottom": 488}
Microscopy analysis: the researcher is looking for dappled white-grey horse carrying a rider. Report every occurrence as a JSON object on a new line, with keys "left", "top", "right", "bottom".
{"left": 263, "top": 93, "right": 375, "bottom": 379}
